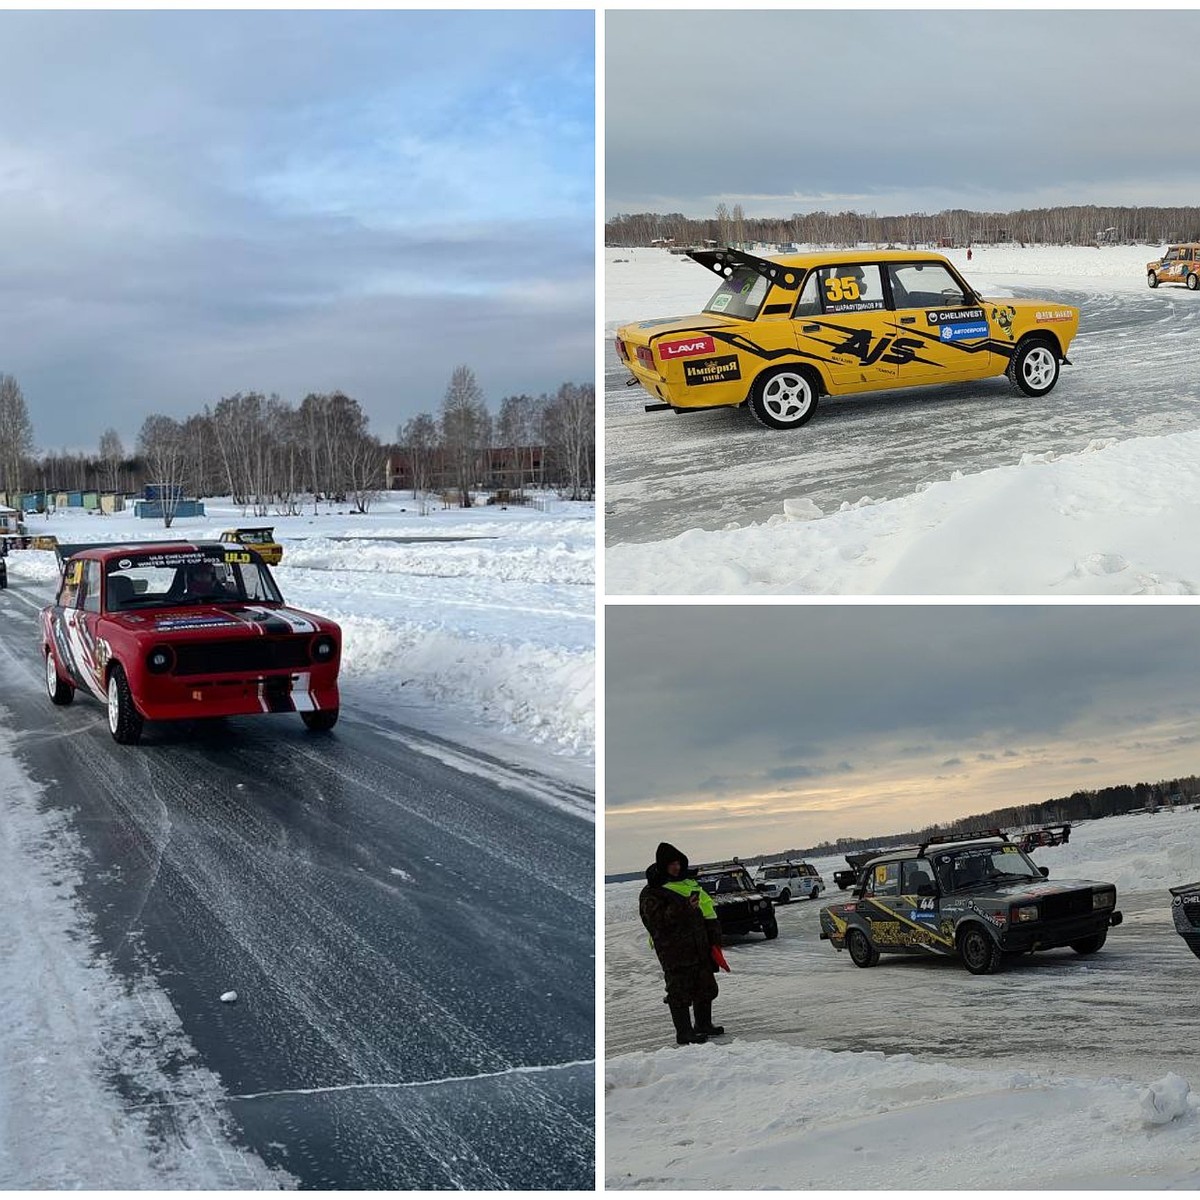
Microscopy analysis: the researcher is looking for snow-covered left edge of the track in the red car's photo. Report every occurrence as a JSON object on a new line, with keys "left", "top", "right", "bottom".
{"left": 0, "top": 729, "right": 290, "bottom": 1190}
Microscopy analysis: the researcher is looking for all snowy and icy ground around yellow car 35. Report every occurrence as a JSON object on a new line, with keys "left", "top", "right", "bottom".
{"left": 605, "top": 246, "right": 1200, "bottom": 595}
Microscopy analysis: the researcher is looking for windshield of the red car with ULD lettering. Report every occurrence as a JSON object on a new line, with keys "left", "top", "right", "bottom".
{"left": 106, "top": 550, "right": 283, "bottom": 612}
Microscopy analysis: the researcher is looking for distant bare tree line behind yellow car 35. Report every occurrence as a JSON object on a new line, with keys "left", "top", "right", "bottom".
{"left": 605, "top": 204, "right": 1200, "bottom": 246}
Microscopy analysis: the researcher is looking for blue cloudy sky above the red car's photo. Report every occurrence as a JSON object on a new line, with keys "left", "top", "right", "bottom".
{"left": 0, "top": 11, "right": 595, "bottom": 450}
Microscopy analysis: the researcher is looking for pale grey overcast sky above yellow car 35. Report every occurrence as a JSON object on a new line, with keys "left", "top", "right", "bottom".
{"left": 605, "top": 8, "right": 1200, "bottom": 217}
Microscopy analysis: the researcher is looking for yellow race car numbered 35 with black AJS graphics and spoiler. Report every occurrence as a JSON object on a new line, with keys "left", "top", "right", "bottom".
{"left": 617, "top": 248, "right": 1079, "bottom": 430}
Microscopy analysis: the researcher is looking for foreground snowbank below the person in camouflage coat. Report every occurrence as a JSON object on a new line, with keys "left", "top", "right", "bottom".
{"left": 605, "top": 1042, "right": 1200, "bottom": 1190}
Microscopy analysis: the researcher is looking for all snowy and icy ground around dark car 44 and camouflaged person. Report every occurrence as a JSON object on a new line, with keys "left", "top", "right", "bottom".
{"left": 605, "top": 810, "right": 1200, "bottom": 1190}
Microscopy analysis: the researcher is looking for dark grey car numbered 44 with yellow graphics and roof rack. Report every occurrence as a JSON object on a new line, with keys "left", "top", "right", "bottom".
{"left": 821, "top": 829, "right": 1121, "bottom": 974}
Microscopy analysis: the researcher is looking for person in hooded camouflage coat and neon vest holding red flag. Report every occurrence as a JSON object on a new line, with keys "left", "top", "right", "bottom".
{"left": 637, "top": 842, "right": 725, "bottom": 1045}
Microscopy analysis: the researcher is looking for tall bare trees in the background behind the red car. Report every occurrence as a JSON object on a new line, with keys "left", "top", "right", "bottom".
{"left": 0, "top": 366, "right": 595, "bottom": 523}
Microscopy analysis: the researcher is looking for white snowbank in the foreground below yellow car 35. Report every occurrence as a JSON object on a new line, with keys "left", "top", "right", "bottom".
{"left": 606, "top": 432, "right": 1200, "bottom": 595}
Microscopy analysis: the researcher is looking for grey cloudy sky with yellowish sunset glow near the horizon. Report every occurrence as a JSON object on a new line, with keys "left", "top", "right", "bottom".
{"left": 605, "top": 605, "right": 1200, "bottom": 871}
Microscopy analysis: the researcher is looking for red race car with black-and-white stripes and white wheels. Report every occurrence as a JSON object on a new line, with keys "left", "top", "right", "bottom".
{"left": 42, "top": 542, "right": 342, "bottom": 744}
